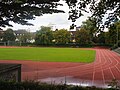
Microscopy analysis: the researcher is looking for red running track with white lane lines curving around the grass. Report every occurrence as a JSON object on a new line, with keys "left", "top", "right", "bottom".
{"left": 0, "top": 48, "right": 120, "bottom": 87}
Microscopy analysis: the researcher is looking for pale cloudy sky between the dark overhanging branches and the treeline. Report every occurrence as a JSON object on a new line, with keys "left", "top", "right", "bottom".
{"left": 3, "top": 1, "right": 91, "bottom": 32}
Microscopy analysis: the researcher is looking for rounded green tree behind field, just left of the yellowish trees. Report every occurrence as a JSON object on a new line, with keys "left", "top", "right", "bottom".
{"left": 35, "top": 26, "right": 53, "bottom": 45}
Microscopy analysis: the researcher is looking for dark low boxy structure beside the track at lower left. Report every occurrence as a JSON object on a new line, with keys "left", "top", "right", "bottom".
{"left": 0, "top": 63, "right": 21, "bottom": 82}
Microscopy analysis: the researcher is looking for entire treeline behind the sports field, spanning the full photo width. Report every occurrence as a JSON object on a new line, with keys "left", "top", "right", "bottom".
{"left": 0, "top": 18, "right": 120, "bottom": 47}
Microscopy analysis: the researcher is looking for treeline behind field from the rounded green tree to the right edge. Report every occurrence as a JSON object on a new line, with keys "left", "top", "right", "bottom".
{"left": 35, "top": 18, "right": 120, "bottom": 46}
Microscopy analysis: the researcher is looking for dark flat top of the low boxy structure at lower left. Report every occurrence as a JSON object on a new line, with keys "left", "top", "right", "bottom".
{"left": 0, "top": 63, "right": 21, "bottom": 74}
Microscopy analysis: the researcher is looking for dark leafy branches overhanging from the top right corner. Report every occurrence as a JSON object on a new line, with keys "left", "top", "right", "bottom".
{"left": 66, "top": 0, "right": 120, "bottom": 28}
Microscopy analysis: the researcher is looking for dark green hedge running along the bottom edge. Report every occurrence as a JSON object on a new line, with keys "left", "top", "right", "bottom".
{"left": 0, "top": 81, "right": 113, "bottom": 90}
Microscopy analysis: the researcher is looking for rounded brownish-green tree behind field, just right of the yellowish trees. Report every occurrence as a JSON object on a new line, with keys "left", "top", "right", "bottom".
{"left": 75, "top": 28, "right": 90, "bottom": 45}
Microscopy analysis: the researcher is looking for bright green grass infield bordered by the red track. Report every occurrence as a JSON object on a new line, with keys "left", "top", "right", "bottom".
{"left": 0, "top": 48, "right": 95, "bottom": 62}
